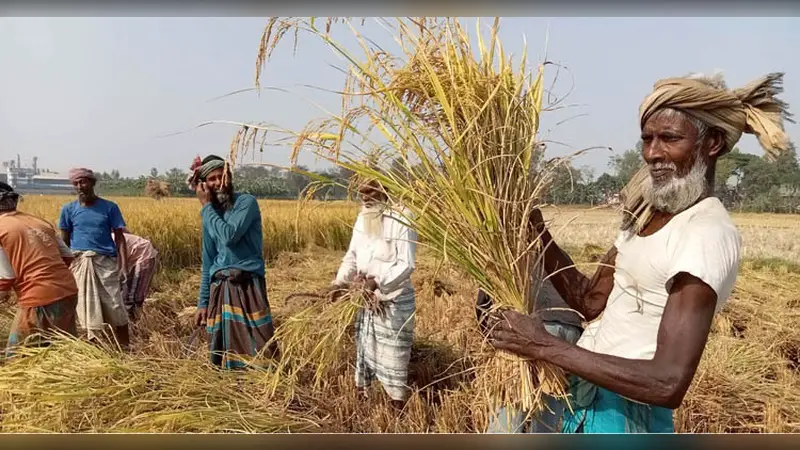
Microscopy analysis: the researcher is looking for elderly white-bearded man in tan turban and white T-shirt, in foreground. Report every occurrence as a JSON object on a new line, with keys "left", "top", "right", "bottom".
{"left": 489, "top": 74, "right": 791, "bottom": 433}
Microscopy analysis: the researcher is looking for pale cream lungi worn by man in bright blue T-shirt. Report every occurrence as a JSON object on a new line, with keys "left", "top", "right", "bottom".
{"left": 70, "top": 251, "right": 128, "bottom": 339}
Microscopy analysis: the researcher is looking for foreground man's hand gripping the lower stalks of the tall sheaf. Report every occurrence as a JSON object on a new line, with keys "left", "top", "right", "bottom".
{"left": 489, "top": 310, "right": 552, "bottom": 359}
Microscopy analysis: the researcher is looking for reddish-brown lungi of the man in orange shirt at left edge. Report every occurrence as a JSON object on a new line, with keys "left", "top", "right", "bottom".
{"left": 6, "top": 295, "right": 78, "bottom": 357}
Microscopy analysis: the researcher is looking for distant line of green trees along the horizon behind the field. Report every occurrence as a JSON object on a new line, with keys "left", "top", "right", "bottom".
{"left": 99, "top": 144, "right": 800, "bottom": 213}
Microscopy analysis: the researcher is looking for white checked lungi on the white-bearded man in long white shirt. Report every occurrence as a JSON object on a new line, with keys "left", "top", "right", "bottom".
{"left": 355, "top": 288, "right": 416, "bottom": 401}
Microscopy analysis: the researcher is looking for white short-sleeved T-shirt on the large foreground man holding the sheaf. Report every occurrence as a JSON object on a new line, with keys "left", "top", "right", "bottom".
{"left": 577, "top": 197, "right": 741, "bottom": 360}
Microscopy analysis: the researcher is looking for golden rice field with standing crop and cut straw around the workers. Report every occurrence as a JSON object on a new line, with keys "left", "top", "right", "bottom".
{"left": 0, "top": 197, "right": 800, "bottom": 432}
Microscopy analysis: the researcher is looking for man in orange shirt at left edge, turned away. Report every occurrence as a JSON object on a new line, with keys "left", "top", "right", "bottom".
{"left": 0, "top": 182, "right": 78, "bottom": 356}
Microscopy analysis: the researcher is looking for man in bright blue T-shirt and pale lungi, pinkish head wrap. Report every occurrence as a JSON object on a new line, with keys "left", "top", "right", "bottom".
{"left": 58, "top": 169, "right": 130, "bottom": 349}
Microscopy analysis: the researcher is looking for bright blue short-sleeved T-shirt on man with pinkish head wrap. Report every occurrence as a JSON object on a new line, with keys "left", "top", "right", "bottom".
{"left": 58, "top": 198, "right": 125, "bottom": 257}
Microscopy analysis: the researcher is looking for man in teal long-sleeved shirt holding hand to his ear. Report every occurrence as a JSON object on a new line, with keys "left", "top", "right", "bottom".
{"left": 189, "top": 155, "right": 277, "bottom": 369}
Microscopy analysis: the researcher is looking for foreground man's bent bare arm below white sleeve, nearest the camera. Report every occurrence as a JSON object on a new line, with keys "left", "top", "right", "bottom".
{"left": 510, "top": 273, "right": 717, "bottom": 409}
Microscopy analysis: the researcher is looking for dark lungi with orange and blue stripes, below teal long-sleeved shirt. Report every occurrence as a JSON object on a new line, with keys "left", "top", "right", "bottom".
{"left": 206, "top": 270, "right": 275, "bottom": 369}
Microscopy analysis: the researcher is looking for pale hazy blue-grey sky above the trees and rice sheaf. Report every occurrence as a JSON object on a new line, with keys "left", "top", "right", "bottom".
{"left": 0, "top": 17, "right": 800, "bottom": 176}
